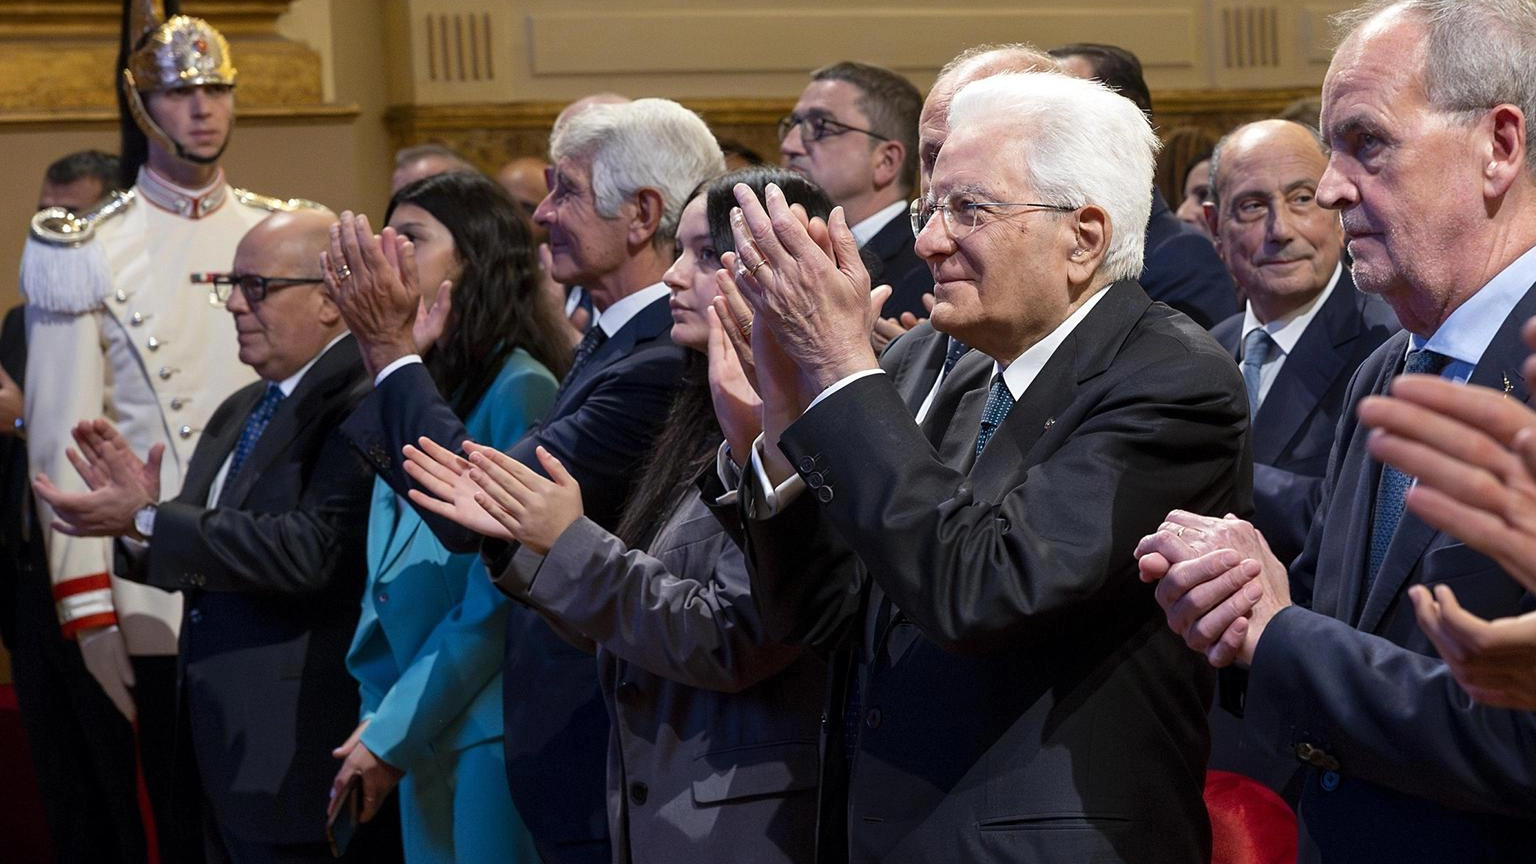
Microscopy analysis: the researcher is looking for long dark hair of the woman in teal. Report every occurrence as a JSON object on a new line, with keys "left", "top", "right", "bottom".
{"left": 384, "top": 172, "right": 571, "bottom": 417}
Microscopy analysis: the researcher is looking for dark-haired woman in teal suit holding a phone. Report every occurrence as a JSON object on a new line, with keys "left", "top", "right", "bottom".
{"left": 335, "top": 174, "right": 570, "bottom": 864}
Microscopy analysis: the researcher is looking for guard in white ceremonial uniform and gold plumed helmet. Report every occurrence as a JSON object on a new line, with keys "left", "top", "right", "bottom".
{"left": 22, "top": 0, "right": 316, "bottom": 859}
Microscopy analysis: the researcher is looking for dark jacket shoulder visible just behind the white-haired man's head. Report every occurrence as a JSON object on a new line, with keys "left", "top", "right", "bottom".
{"left": 1140, "top": 189, "right": 1238, "bottom": 329}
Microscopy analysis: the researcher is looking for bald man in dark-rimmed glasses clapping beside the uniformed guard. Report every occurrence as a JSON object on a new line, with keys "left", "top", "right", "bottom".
{"left": 35, "top": 209, "right": 399, "bottom": 861}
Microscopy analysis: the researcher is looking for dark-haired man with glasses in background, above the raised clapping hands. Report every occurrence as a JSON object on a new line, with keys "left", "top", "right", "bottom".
{"left": 779, "top": 61, "right": 934, "bottom": 322}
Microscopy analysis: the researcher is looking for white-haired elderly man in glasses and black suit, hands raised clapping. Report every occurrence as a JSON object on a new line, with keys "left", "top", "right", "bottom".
{"left": 723, "top": 72, "right": 1250, "bottom": 862}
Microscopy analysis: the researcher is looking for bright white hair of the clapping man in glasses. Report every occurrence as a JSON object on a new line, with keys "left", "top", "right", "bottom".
{"left": 949, "top": 72, "right": 1160, "bottom": 280}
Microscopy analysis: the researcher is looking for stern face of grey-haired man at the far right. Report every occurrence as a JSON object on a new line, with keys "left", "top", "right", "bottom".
{"left": 1318, "top": 12, "right": 1484, "bottom": 300}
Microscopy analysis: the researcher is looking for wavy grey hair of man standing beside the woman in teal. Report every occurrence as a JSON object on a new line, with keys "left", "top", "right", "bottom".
{"left": 550, "top": 98, "right": 725, "bottom": 249}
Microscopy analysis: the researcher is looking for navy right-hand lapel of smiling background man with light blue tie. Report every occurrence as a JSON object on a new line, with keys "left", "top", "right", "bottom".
{"left": 1253, "top": 279, "right": 1362, "bottom": 464}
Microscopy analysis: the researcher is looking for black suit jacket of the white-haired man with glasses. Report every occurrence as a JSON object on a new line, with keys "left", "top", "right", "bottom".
{"left": 743, "top": 281, "right": 1249, "bottom": 862}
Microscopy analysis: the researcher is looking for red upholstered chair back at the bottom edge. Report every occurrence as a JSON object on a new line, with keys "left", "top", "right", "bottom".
{"left": 1206, "top": 772, "right": 1296, "bottom": 864}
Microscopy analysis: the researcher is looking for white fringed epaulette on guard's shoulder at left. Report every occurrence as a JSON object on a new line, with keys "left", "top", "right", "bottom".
{"left": 22, "top": 189, "right": 134, "bottom": 315}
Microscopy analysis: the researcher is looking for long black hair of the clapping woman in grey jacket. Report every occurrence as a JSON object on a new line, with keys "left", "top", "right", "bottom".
{"left": 616, "top": 166, "right": 833, "bottom": 549}
